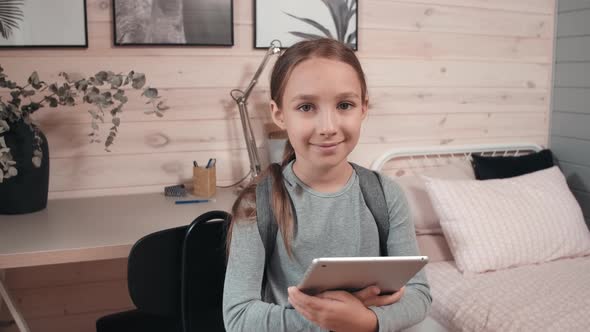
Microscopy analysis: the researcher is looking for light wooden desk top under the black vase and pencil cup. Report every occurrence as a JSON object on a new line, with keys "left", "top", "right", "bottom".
{"left": 0, "top": 189, "right": 236, "bottom": 269}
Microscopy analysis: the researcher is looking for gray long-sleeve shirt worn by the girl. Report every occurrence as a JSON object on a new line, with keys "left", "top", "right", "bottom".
{"left": 223, "top": 163, "right": 432, "bottom": 331}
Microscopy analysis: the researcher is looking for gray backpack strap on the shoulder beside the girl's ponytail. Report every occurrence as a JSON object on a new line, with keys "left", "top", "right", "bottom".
{"left": 256, "top": 175, "right": 278, "bottom": 295}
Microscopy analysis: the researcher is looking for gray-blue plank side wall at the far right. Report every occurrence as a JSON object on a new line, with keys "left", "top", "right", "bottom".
{"left": 550, "top": 0, "right": 590, "bottom": 227}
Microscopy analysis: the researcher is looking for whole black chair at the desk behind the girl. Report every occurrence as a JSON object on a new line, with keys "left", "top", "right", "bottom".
{"left": 96, "top": 211, "right": 229, "bottom": 332}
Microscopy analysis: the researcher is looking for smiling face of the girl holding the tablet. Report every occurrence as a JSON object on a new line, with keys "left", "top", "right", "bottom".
{"left": 271, "top": 58, "right": 367, "bottom": 169}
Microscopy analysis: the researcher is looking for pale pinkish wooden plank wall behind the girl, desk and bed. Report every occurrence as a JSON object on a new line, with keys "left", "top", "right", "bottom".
{"left": 0, "top": 0, "right": 555, "bottom": 332}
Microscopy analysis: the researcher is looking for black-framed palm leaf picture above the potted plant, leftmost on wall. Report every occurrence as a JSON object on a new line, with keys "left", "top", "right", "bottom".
{"left": 0, "top": 0, "right": 88, "bottom": 47}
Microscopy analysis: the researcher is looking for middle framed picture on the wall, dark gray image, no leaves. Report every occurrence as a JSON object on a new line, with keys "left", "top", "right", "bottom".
{"left": 113, "top": 0, "right": 234, "bottom": 46}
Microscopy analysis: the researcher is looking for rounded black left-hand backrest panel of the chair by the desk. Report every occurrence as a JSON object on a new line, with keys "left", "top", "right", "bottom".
{"left": 127, "top": 226, "right": 188, "bottom": 319}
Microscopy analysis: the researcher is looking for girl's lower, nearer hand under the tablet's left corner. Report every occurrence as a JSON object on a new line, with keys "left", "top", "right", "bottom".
{"left": 288, "top": 287, "right": 378, "bottom": 332}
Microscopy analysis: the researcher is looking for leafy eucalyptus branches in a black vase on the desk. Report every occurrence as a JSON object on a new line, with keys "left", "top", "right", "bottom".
{"left": 0, "top": 66, "right": 168, "bottom": 214}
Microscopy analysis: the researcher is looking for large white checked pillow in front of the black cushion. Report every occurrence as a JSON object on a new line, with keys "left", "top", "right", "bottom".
{"left": 425, "top": 166, "right": 590, "bottom": 272}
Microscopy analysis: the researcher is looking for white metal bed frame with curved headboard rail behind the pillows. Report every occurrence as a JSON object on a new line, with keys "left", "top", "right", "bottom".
{"left": 371, "top": 143, "right": 543, "bottom": 332}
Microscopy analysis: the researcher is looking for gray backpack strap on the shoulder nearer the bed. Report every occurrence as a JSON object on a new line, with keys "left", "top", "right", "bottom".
{"left": 350, "top": 163, "right": 389, "bottom": 256}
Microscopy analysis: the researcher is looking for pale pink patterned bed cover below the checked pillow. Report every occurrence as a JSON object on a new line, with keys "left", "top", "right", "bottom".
{"left": 426, "top": 256, "right": 590, "bottom": 331}
